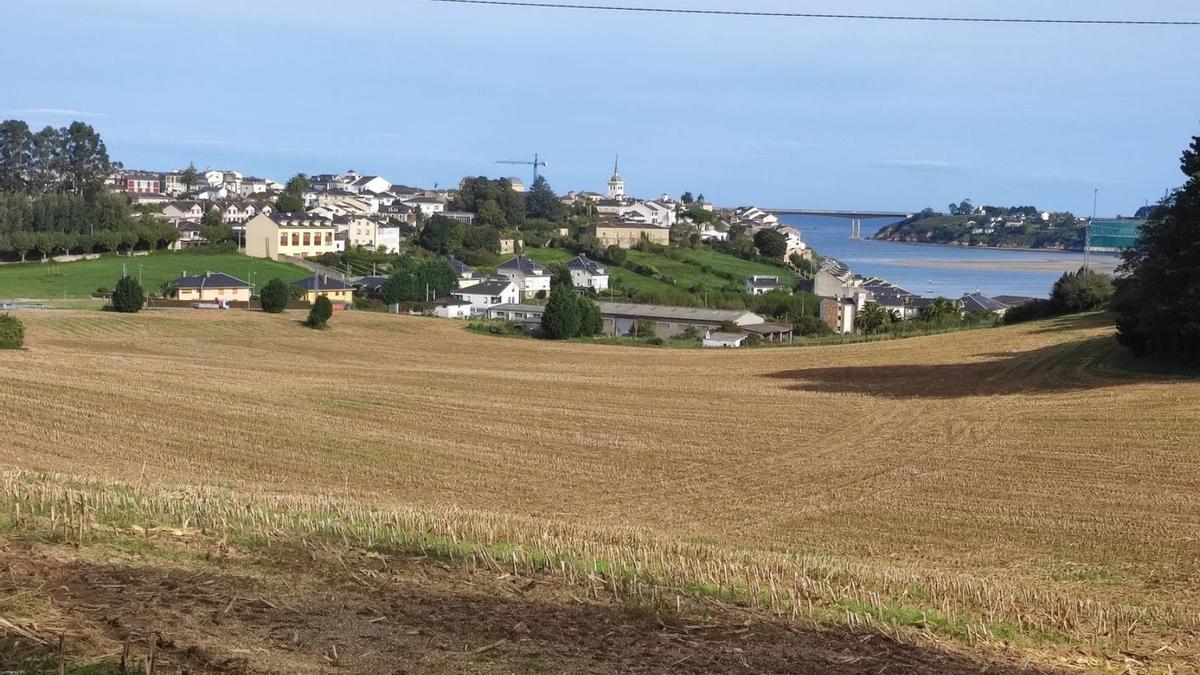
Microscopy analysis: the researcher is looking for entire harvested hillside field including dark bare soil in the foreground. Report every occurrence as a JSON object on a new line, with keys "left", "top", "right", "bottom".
{"left": 0, "top": 310, "right": 1200, "bottom": 673}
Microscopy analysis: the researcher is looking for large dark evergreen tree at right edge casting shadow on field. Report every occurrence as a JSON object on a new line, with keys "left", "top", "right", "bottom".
{"left": 1112, "top": 136, "right": 1200, "bottom": 363}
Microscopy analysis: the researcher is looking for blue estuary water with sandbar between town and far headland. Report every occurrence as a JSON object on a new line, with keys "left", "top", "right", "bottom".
{"left": 780, "top": 216, "right": 1120, "bottom": 298}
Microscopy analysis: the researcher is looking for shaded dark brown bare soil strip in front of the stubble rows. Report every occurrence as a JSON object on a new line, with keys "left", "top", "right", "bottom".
{"left": 0, "top": 538, "right": 1060, "bottom": 673}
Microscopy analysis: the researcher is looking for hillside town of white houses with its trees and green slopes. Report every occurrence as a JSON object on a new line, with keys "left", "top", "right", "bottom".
{"left": 0, "top": 120, "right": 1069, "bottom": 347}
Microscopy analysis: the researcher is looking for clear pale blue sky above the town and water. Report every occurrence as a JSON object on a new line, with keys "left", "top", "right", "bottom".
{"left": 0, "top": 0, "right": 1200, "bottom": 215}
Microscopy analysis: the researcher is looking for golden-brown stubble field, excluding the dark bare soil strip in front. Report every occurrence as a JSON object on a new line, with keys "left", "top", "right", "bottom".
{"left": 0, "top": 310, "right": 1200, "bottom": 671}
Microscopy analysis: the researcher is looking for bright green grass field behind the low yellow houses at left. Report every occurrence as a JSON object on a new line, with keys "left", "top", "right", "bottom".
{"left": 0, "top": 251, "right": 310, "bottom": 299}
